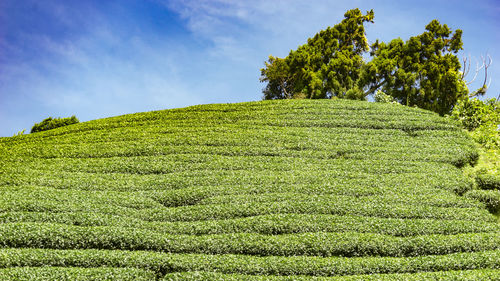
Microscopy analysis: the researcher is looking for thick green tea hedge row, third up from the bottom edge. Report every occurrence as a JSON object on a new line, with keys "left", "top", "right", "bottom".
{"left": 0, "top": 223, "right": 500, "bottom": 257}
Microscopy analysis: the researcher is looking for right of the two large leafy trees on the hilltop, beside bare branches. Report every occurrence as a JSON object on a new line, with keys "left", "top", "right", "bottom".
{"left": 362, "top": 20, "right": 468, "bottom": 115}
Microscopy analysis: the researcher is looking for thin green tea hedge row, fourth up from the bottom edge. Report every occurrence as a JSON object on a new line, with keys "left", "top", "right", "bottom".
{"left": 0, "top": 212, "right": 500, "bottom": 237}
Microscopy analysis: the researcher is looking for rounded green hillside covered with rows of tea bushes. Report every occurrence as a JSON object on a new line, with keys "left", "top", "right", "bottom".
{"left": 0, "top": 100, "right": 500, "bottom": 280}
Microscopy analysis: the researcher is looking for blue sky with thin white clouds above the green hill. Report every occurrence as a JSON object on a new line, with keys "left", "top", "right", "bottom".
{"left": 0, "top": 0, "right": 500, "bottom": 136}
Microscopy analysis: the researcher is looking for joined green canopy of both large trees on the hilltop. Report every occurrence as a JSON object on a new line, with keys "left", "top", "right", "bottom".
{"left": 260, "top": 9, "right": 468, "bottom": 115}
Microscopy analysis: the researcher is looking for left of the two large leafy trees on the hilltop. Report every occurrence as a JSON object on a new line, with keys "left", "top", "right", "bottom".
{"left": 260, "top": 9, "right": 373, "bottom": 99}
